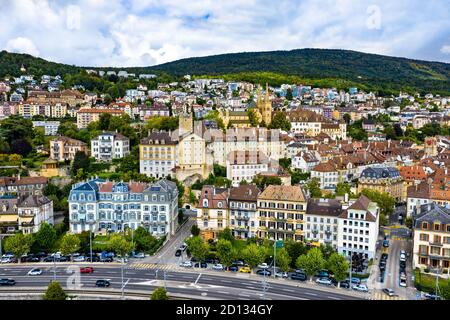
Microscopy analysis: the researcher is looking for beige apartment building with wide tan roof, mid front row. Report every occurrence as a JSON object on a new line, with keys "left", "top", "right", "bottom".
{"left": 257, "top": 185, "right": 307, "bottom": 241}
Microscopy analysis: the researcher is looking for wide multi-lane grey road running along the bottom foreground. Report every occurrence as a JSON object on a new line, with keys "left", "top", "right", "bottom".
{"left": 0, "top": 264, "right": 364, "bottom": 300}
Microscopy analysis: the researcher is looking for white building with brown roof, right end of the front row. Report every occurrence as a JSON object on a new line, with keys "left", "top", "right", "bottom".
{"left": 337, "top": 196, "right": 380, "bottom": 259}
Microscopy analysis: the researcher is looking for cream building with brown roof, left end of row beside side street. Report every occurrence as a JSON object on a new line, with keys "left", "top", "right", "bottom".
{"left": 197, "top": 186, "right": 229, "bottom": 239}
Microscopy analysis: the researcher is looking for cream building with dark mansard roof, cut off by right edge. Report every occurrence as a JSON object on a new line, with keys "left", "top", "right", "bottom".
{"left": 413, "top": 203, "right": 450, "bottom": 270}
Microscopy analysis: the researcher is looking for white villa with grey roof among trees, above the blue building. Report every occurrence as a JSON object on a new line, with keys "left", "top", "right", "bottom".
{"left": 91, "top": 132, "right": 130, "bottom": 161}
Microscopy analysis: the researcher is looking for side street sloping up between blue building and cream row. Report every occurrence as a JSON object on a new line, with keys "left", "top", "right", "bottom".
{"left": 141, "top": 217, "right": 195, "bottom": 265}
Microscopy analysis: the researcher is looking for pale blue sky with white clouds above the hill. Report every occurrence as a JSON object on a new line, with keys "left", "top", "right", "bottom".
{"left": 0, "top": 0, "right": 450, "bottom": 67}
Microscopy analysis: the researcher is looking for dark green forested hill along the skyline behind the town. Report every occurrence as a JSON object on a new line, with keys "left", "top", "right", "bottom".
{"left": 0, "top": 49, "right": 450, "bottom": 95}
